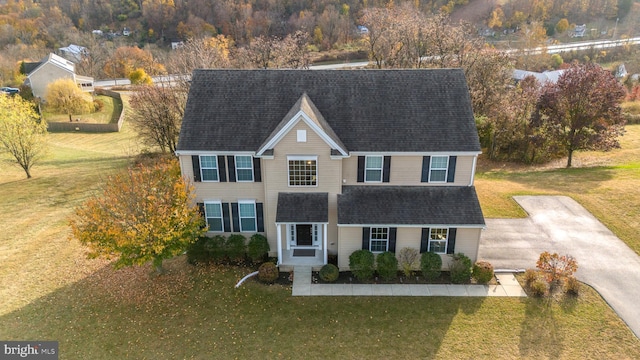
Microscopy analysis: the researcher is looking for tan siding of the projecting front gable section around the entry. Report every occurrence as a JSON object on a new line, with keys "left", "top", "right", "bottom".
{"left": 262, "top": 121, "right": 342, "bottom": 254}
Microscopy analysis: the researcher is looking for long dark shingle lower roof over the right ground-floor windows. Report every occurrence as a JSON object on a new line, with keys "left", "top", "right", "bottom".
{"left": 338, "top": 186, "right": 485, "bottom": 226}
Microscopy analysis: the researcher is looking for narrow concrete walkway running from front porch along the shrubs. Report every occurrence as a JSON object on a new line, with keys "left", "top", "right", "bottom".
{"left": 291, "top": 266, "right": 527, "bottom": 297}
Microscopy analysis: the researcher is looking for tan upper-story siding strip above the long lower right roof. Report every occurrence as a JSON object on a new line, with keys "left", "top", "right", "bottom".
{"left": 342, "top": 155, "right": 474, "bottom": 186}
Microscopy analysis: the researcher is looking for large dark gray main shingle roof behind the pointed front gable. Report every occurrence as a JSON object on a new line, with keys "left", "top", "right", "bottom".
{"left": 178, "top": 69, "right": 480, "bottom": 152}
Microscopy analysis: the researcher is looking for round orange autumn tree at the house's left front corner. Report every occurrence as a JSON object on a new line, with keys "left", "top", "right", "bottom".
{"left": 70, "top": 159, "right": 205, "bottom": 273}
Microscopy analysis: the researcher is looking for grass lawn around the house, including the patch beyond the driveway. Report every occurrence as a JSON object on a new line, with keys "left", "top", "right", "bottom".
{"left": 0, "top": 118, "right": 640, "bottom": 359}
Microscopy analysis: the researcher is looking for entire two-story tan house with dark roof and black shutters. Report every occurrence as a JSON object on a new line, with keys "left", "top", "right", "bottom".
{"left": 176, "top": 69, "right": 484, "bottom": 270}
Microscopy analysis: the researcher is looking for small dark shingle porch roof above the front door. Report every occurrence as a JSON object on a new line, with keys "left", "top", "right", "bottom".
{"left": 276, "top": 192, "right": 329, "bottom": 223}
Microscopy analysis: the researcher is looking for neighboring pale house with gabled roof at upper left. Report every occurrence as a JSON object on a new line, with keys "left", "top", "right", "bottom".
{"left": 25, "top": 53, "right": 94, "bottom": 98}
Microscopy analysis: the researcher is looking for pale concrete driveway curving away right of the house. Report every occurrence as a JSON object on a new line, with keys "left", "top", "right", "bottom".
{"left": 478, "top": 196, "right": 640, "bottom": 337}
